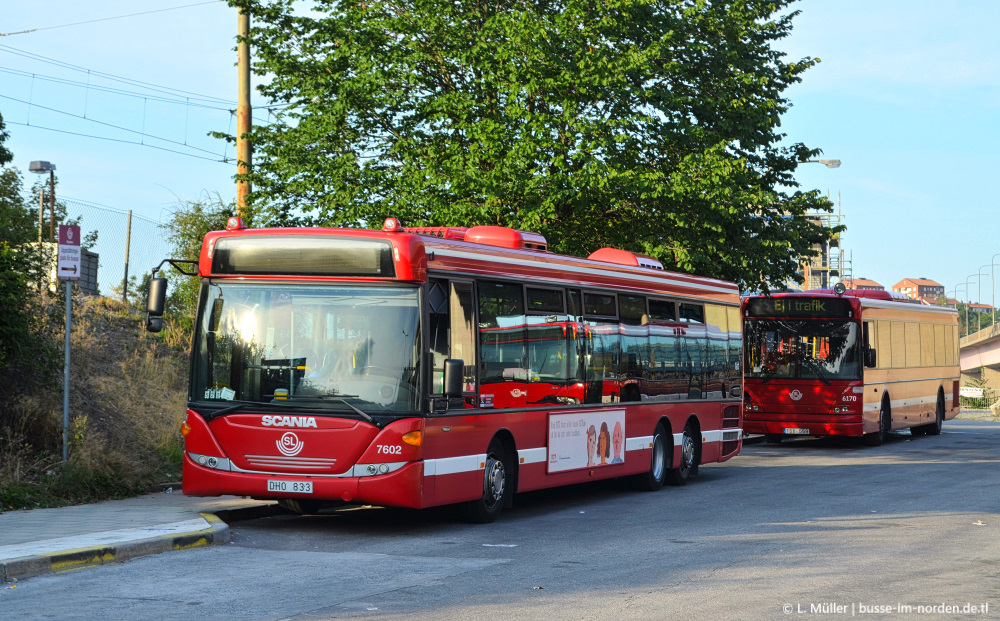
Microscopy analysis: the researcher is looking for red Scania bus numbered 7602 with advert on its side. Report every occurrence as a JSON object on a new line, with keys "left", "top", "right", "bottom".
{"left": 149, "top": 219, "right": 742, "bottom": 522}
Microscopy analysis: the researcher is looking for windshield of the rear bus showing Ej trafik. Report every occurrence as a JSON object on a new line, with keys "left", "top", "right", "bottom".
{"left": 743, "top": 319, "right": 861, "bottom": 383}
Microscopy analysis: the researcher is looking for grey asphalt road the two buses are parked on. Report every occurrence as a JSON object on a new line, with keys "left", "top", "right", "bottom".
{"left": 0, "top": 421, "right": 1000, "bottom": 621}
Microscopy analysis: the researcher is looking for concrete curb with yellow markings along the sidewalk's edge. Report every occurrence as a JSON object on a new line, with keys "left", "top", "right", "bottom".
{"left": 0, "top": 507, "right": 232, "bottom": 582}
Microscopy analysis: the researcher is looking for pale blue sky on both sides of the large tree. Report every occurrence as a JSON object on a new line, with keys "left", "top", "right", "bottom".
{"left": 0, "top": 0, "right": 1000, "bottom": 303}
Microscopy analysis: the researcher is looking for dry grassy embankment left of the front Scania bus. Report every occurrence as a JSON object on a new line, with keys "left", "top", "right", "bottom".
{"left": 0, "top": 296, "right": 190, "bottom": 511}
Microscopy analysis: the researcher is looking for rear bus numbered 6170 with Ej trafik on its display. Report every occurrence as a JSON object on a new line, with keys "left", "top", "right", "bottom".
{"left": 742, "top": 285, "right": 960, "bottom": 446}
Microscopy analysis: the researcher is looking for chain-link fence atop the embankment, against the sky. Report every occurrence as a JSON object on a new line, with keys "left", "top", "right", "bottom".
{"left": 55, "top": 199, "right": 170, "bottom": 299}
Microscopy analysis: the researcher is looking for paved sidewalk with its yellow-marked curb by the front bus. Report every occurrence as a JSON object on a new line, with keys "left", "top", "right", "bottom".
{"left": 0, "top": 487, "right": 282, "bottom": 582}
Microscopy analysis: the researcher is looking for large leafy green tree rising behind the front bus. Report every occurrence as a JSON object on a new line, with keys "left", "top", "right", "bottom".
{"left": 230, "top": 0, "right": 839, "bottom": 290}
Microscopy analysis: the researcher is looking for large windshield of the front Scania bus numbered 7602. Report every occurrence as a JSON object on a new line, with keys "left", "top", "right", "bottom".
{"left": 191, "top": 282, "right": 420, "bottom": 413}
